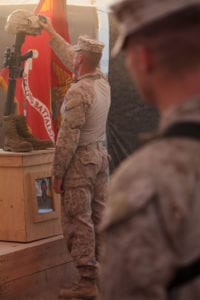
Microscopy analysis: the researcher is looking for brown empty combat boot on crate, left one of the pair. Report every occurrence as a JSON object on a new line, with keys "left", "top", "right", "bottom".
{"left": 3, "top": 115, "right": 33, "bottom": 152}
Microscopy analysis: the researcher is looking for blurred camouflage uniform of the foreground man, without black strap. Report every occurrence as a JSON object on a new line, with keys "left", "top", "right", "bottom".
{"left": 101, "top": 97, "right": 200, "bottom": 300}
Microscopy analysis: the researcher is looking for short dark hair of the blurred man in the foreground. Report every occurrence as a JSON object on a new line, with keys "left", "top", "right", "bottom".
{"left": 125, "top": 5, "right": 200, "bottom": 74}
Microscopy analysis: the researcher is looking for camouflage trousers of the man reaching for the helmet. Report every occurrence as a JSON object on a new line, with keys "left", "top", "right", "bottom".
{"left": 61, "top": 146, "right": 108, "bottom": 279}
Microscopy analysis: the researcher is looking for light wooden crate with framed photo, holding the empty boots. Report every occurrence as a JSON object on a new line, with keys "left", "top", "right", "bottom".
{"left": 0, "top": 149, "right": 62, "bottom": 242}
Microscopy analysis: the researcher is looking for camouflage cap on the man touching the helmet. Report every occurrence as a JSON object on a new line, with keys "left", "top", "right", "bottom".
{"left": 74, "top": 36, "right": 105, "bottom": 53}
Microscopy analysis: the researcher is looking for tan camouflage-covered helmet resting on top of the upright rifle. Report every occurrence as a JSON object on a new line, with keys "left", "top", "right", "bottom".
{"left": 5, "top": 9, "right": 42, "bottom": 35}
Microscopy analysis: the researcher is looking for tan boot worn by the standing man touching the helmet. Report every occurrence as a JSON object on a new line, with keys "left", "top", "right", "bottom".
{"left": 59, "top": 278, "right": 98, "bottom": 300}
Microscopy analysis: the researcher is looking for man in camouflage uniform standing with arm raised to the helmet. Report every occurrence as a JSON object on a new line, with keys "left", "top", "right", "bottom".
{"left": 39, "top": 20, "right": 110, "bottom": 298}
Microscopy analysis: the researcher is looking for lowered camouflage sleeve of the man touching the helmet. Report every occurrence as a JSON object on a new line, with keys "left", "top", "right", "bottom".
{"left": 53, "top": 82, "right": 93, "bottom": 178}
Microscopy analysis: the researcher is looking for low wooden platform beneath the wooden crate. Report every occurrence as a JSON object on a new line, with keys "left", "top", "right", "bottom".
{"left": 0, "top": 235, "right": 77, "bottom": 300}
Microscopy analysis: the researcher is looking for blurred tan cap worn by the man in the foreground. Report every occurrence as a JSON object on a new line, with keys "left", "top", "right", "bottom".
{"left": 111, "top": 0, "right": 200, "bottom": 55}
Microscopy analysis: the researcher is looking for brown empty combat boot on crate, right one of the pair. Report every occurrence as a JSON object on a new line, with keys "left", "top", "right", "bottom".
{"left": 16, "top": 115, "right": 54, "bottom": 150}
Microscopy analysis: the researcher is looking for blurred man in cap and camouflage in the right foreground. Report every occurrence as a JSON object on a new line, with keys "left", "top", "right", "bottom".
{"left": 101, "top": 0, "right": 200, "bottom": 300}
